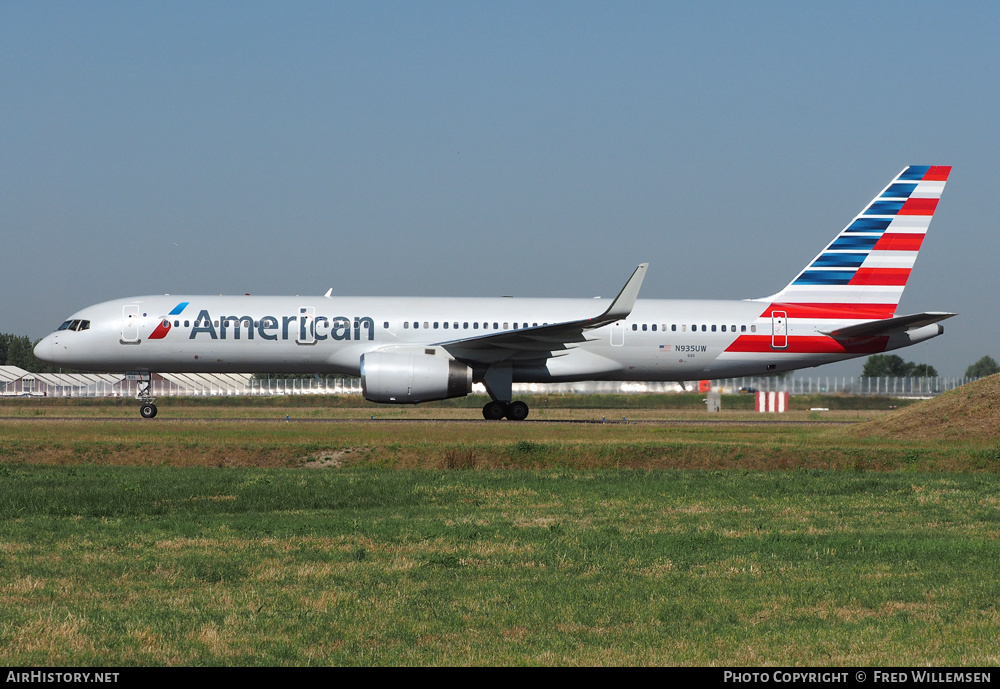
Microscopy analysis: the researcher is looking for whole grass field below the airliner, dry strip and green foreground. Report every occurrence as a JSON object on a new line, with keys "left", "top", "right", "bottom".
{"left": 0, "top": 396, "right": 1000, "bottom": 666}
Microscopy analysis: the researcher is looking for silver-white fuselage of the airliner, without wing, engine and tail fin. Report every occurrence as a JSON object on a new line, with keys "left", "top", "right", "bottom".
{"left": 36, "top": 295, "right": 920, "bottom": 382}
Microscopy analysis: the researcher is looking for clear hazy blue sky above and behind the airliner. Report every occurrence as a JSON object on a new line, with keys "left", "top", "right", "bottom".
{"left": 0, "top": 1, "right": 1000, "bottom": 375}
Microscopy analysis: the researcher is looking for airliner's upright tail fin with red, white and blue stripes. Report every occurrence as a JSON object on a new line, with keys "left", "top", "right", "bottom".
{"left": 757, "top": 165, "right": 951, "bottom": 318}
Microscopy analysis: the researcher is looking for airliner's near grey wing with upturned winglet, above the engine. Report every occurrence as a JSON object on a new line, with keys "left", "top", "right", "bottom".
{"left": 434, "top": 263, "right": 649, "bottom": 363}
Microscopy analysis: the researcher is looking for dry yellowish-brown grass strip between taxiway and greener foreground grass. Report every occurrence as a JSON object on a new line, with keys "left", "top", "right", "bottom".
{"left": 0, "top": 420, "right": 1000, "bottom": 471}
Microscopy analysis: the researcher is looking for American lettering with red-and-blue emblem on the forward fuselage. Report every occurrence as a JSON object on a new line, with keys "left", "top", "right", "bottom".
{"left": 149, "top": 302, "right": 375, "bottom": 342}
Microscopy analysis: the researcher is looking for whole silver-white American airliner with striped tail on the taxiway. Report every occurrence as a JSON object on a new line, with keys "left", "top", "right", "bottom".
{"left": 35, "top": 165, "right": 956, "bottom": 421}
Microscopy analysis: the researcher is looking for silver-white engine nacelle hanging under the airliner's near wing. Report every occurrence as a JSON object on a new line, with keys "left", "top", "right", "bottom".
{"left": 361, "top": 352, "right": 472, "bottom": 404}
